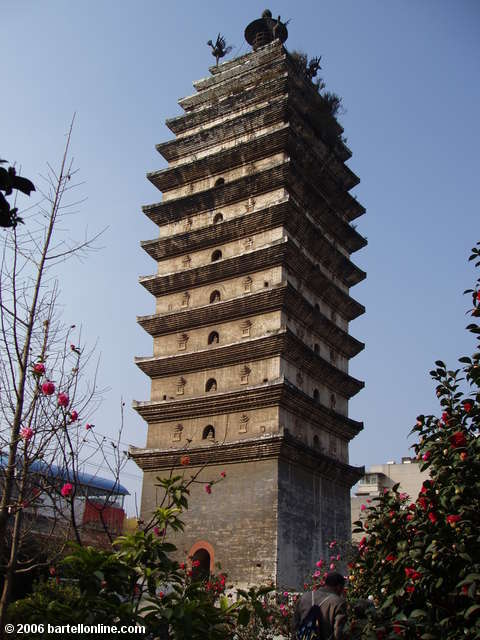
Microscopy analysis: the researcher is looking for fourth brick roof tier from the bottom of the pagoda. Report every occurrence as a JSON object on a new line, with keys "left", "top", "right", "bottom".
{"left": 137, "top": 283, "right": 365, "bottom": 358}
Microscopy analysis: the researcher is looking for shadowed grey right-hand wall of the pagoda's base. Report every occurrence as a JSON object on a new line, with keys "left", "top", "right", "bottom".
{"left": 277, "top": 460, "right": 350, "bottom": 591}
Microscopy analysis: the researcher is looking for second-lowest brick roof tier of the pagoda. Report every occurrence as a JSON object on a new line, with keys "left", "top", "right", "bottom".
{"left": 133, "top": 378, "right": 363, "bottom": 440}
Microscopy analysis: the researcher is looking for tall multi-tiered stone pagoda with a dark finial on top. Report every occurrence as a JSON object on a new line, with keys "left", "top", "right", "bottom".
{"left": 131, "top": 12, "right": 366, "bottom": 588}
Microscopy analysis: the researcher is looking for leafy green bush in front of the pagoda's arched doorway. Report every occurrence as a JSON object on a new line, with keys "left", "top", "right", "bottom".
{"left": 8, "top": 468, "right": 285, "bottom": 640}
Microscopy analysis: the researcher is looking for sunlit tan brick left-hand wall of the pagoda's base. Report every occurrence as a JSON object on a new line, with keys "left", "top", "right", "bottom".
{"left": 142, "top": 459, "right": 278, "bottom": 586}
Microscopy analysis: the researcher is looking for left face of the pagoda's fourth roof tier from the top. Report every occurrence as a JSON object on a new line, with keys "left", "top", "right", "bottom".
{"left": 165, "top": 76, "right": 288, "bottom": 135}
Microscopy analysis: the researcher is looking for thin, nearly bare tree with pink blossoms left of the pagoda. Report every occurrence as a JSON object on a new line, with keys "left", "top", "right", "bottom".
{"left": 0, "top": 120, "right": 120, "bottom": 628}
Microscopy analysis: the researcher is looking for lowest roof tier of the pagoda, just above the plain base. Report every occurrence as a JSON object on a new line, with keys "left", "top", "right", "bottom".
{"left": 129, "top": 433, "right": 365, "bottom": 488}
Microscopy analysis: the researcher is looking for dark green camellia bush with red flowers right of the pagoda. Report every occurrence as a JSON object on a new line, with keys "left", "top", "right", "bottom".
{"left": 349, "top": 243, "right": 480, "bottom": 640}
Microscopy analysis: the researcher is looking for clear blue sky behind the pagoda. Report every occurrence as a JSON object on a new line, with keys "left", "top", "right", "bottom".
{"left": 0, "top": 0, "right": 480, "bottom": 510}
